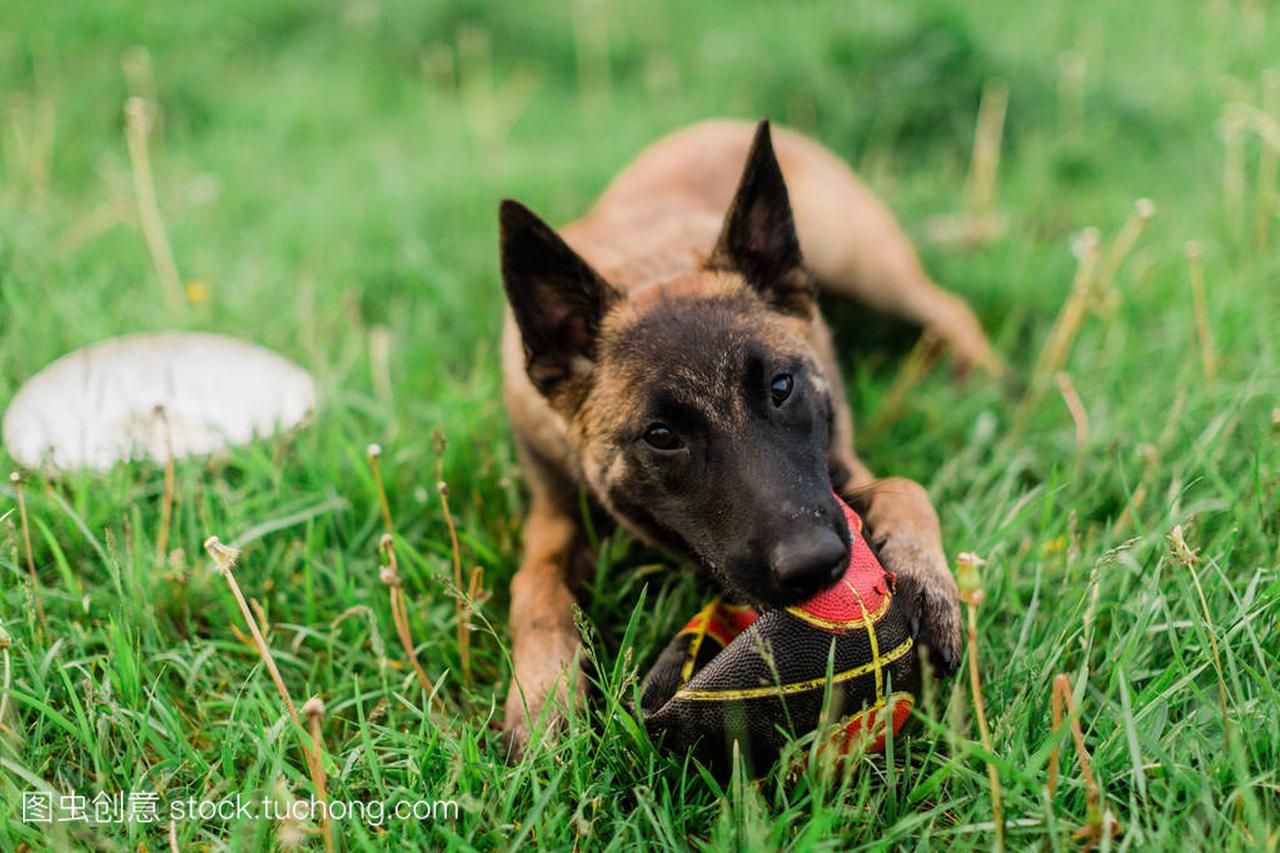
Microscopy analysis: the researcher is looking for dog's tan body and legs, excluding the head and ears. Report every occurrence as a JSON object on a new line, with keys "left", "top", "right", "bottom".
{"left": 503, "top": 120, "right": 1000, "bottom": 749}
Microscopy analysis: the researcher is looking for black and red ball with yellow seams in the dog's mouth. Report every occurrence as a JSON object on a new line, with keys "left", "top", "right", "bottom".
{"left": 640, "top": 502, "right": 919, "bottom": 774}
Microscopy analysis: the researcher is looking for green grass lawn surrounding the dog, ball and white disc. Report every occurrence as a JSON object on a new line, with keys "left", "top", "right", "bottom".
{"left": 0, "top": 0, "right": 1280, "bottom": 849}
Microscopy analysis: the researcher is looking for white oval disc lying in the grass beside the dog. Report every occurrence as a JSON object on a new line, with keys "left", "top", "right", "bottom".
{"left": 4, "top": 332, "right": 316, "bottom": 471}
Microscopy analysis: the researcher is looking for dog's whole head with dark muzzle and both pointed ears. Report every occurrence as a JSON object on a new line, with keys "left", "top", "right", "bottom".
{"left": 502, "top": 122, "right": 849, "bottom": 606}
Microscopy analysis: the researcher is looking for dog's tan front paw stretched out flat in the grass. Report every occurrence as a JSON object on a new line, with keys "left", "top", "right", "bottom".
{"left": 502, "top": 630, "right": 585, "bottom": 762}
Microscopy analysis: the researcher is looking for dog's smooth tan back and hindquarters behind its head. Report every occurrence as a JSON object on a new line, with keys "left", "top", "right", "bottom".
{"left": 545, "top": 119, "right": 998, "bottom": 369}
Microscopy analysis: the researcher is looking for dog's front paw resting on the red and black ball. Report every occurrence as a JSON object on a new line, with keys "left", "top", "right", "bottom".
{"left": 878, "top": 538, "right": 961, "bottom": 678}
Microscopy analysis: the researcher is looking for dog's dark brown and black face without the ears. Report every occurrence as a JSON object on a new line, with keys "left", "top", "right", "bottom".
{"left": 589, "top": 297, "right": 850, "bottom": 606}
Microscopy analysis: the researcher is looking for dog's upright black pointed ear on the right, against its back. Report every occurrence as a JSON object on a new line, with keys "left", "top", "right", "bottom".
{"left": 707, "top": 119, "right": 815, "bottom": 316}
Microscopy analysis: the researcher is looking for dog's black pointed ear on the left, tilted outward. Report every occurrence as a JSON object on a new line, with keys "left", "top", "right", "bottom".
{"left": 499, "top": 199, "right": 618, "bottom": 402}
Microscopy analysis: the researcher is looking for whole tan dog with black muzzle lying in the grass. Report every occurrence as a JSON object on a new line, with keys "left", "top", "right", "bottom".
{"left": 500, "top": 116, "right": 998, "bottom": 754}
